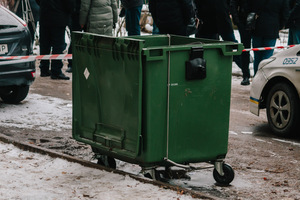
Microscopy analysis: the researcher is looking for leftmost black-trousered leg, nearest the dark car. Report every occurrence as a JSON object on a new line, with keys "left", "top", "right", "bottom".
{"left": 40, "top": 24, "right": 51, "bottom": 77}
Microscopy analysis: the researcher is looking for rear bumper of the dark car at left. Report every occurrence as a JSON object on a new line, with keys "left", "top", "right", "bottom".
{"left": 0, "top": 57, "right": 35, "bottom": 87}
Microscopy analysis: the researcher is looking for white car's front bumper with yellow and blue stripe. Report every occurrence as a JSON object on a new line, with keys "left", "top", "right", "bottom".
{"left": 250, "top": 69, "right": 268, "bottom": 116}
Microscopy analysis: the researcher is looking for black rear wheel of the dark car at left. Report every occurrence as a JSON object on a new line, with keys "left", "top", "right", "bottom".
{"left": 1, "top": 85, "right": 29, "bottom": 104}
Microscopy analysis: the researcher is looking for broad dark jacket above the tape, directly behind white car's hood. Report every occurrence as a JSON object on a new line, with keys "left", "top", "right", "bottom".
{"left": 249, "top": 0, "right": 289, "bottom": 39}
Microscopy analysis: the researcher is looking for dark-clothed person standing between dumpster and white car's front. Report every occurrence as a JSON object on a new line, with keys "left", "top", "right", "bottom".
{"left": 230, "top": 0, "right": 251, "bottom": 85}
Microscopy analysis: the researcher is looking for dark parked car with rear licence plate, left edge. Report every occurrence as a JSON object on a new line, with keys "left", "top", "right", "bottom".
{"left": 0, "top": 5, "right": 35, "bottom": 104}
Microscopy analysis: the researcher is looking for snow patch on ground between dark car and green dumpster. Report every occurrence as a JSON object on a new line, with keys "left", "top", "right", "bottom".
{"left": 0, "top": 93, "right": 72, "bottom": 131}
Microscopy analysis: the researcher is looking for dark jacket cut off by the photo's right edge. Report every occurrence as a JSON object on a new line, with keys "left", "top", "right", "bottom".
{"left": 286, "top": 0, "right": 300, "bottom": 29}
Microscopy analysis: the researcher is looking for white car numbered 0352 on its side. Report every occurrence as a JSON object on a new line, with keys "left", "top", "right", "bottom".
{"left": 250, "top": 45, "right": 300, "bottom": 136}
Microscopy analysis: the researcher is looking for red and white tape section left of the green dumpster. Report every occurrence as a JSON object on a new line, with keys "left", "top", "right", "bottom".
{"left": 0, "top": 54, "right": 72, "bottom": 60}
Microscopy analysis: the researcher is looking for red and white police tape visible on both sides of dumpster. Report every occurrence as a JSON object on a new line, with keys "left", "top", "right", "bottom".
{"left": 0, "top": 45, "right": 296, "bottom": 60}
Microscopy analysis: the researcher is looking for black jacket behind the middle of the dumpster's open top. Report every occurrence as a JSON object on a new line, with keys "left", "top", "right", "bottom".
{"left": 149, "top": 0, "right": 196, "bottom": 34}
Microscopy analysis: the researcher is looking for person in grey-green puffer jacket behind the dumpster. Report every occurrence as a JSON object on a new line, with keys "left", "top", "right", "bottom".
{"left": 79, "top": 0, "right": 118, "bottom": 36}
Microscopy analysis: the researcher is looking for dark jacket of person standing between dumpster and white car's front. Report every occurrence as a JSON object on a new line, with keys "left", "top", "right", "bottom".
{"left": 230, "top": 0, "right": 251, "bottom": 25}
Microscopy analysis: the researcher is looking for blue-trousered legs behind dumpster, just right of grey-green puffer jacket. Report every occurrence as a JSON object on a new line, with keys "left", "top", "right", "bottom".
{"left": 125, "top": 6, "right": 142, "bottom": 36}
